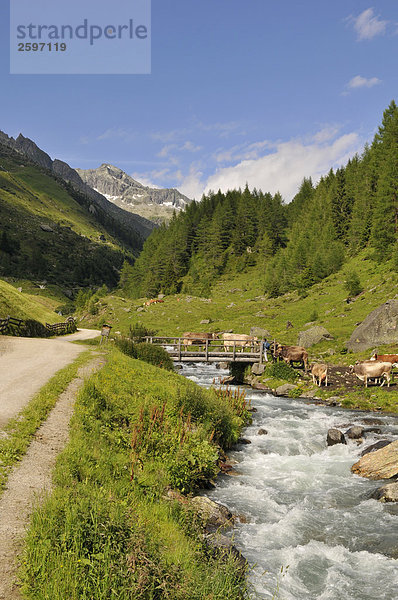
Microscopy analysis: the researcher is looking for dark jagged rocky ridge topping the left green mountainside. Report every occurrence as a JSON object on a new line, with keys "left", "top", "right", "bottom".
{"left": 0, "top": 131, "right": 154, "bottom": 239}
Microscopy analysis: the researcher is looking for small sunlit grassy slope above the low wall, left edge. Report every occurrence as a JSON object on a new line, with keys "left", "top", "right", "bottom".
{"left": 0, "top": 279, "right": 60, "bottom": 323}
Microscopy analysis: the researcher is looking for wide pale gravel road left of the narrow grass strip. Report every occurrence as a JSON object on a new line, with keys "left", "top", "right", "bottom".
{"left": 0, "top": 329, "right": 100, "bottom": 428}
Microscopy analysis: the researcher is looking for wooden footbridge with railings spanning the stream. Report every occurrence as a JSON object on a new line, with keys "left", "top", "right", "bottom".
{"left": 145, "top": 336, "right": 263, "bottom": 363}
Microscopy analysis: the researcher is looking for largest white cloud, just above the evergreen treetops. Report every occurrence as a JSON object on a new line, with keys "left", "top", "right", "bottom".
{"left": 204, "top": 129, "right": 360, "bottom": 201}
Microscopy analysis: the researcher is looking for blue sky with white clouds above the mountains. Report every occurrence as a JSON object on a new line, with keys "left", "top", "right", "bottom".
{"left": 0, "top": 0, "right": 398, "bottom": 202}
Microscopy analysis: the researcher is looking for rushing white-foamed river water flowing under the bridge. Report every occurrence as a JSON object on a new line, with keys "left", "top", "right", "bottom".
{"left": 181, "top": 364, "right": 398, "bottom": 600}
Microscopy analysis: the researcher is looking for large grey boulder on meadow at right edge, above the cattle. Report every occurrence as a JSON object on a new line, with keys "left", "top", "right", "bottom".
{"left": 347, "top": 300, "right": 398, "bottom": 352}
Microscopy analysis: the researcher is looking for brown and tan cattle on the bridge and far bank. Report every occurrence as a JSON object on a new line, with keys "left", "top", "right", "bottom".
{"left": 183, "top": 331, "right": 398, "bottom": 387}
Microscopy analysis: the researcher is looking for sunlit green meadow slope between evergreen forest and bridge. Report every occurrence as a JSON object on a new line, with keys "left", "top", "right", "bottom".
{"left": 79, "top": 251, "right": 398, "bottom": 360}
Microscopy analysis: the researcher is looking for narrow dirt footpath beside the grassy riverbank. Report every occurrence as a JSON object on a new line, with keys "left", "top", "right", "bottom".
{"left": 0, "top": 356, "right": 104, "bottom": 600}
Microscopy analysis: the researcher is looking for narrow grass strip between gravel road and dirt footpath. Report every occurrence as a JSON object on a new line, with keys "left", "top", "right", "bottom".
{"left": 0, "top": 351, "right": 92, "bottom": 493}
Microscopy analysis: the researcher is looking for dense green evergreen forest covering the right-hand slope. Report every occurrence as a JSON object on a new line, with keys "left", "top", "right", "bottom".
{"left": 121, "top": 101, "right": 398, "bottom": 297}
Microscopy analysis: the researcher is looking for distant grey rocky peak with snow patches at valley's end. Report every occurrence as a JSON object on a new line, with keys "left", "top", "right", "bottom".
{"left": 76, "top": 164, "right": 192, "bottom": 223}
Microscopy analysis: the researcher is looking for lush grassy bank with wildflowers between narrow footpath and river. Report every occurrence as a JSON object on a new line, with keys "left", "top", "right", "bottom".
{"left": 21, "top": 350, "right": 248, "bottom": 600}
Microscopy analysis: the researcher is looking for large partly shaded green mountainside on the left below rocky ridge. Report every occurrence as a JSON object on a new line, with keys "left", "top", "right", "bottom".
{"left": 0, "top": 145, "right": 136, "bottom": 286}
